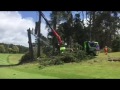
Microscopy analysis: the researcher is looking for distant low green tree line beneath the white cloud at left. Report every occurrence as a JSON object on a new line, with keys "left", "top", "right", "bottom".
{"left": 0, "top": 43, "right": 28, "bottom": 53}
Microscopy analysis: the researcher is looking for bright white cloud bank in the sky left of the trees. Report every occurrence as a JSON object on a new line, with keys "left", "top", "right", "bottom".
{"left": 0, "top": 11, "right": 47, "bottom": 46}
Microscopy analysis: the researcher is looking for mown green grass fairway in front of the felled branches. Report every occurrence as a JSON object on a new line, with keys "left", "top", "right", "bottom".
{"left": 0, "top": 52, "right": 120, "bottom": 79}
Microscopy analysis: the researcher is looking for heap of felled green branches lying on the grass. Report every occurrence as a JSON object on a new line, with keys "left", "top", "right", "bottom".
{"left": 38, "top": 50, "right": 94, "bottom": 66}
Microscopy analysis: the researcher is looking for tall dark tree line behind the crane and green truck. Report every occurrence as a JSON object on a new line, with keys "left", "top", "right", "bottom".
{"left": 46, "top": 11, "right": 120, "bottom": 51}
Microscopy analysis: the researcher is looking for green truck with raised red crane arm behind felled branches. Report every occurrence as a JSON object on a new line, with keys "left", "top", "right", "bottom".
{"left": 35, "top": 12, "right": 99, "bottom": 56}
